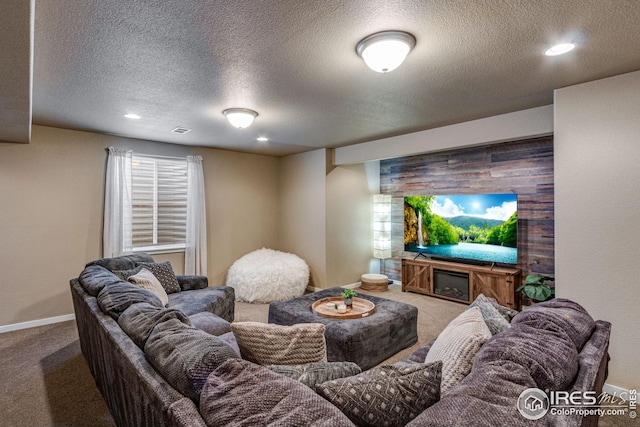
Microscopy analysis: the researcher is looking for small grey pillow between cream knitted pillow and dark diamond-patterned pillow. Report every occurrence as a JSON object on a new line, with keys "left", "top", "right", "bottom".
{"left": 267, "top": 362, "right": 362, "bottom": 391}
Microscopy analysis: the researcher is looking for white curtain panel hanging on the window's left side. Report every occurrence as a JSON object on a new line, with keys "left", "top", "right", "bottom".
{"left": 102, "top": 147, "right": 133, "bottom": 258}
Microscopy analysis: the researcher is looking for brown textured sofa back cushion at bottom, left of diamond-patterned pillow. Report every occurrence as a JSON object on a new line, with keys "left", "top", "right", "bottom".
{"left": 200, "top": 359, "right": 353, "bottom": 427}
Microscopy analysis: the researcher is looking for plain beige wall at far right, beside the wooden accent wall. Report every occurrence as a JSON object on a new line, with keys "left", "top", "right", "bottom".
{"left": 554, "top": 72, "right": 640, "bottom": 389}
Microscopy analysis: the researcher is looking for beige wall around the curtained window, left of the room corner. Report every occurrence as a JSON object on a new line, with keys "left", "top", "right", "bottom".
{"left": 0, "top": 126, "right": 279, "bottom": 326}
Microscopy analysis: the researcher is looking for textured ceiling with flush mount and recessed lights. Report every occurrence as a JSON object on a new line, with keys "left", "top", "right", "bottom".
{"left": 6, "top": 0, "right": 640, "bottom": 155}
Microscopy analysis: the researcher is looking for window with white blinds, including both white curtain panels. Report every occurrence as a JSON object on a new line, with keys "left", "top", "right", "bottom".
{"left": 102, "top": 147, "right": 207, "bottom": 275}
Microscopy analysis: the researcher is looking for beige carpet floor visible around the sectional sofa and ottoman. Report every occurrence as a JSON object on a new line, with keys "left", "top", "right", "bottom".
{"left": 0, "top": 285, "right": 639, "bottom": 427}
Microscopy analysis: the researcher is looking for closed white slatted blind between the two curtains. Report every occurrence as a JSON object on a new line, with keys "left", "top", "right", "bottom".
{"left": 131, "top": 154, "right": 188, "bottom": 251}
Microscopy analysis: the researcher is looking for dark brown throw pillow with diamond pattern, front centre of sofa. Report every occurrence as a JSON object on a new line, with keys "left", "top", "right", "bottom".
{"left": 316, "top": 361, "right": 442, "bottom": 427}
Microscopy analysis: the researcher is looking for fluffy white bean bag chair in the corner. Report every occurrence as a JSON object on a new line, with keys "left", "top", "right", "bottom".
{"left": 227, "top": 248, "right": 309, "bottom": 303}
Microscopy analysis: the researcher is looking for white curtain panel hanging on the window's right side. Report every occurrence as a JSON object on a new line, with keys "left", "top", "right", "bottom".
{"left": 184, "top": 156, "right": 207, "bottom": 276}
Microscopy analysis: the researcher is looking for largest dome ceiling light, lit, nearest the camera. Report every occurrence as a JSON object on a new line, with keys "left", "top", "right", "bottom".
{"left": 356, "top": 31, "right": 416, "bottom": 73}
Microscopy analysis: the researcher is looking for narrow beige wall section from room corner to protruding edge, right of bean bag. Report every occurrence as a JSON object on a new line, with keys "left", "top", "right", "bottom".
{"left": 279, "top": 149, "right": 327, "bottom": 288}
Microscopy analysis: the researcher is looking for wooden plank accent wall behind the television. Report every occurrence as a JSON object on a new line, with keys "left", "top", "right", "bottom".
{"left": 380, "top": 136, "right": 554, "bottom": 280}
